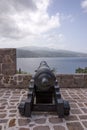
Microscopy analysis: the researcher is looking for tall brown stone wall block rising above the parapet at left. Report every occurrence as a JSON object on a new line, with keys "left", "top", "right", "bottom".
{"left": 0, "top": 48, "right": 16, "bottom": 75}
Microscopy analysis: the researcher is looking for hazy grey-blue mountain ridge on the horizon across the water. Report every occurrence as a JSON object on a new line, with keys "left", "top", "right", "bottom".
{"left": 17, "top": 46, "right": 87, "bottom": 58}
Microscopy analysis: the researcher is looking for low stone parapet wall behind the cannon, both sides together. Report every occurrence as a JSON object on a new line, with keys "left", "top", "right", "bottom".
{"left": 0, "top": 74, "right": 87, "bottom": 88}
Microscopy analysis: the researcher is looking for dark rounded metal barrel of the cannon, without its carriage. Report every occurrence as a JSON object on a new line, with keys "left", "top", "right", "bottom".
{"left": 34, "top": 61, "right": 56, "bottom": 91}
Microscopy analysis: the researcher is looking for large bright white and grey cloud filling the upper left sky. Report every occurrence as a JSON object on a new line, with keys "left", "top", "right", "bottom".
{"left": 0, "top": 0, "right": 60, "bottom": 39}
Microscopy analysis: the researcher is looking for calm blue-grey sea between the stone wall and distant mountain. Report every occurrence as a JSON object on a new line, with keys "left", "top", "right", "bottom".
{"left": 17, "top": 57, "right": 87, "bottom": 74}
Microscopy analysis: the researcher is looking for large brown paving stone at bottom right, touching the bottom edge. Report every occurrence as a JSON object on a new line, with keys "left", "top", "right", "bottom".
{"left": 67, "top": 122, "right": 84, "bottom": 130}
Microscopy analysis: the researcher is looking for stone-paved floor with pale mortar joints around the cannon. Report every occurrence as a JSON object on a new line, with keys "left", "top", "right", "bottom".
{"left": 0, "top": 89, "right": 87, "bottom": 130}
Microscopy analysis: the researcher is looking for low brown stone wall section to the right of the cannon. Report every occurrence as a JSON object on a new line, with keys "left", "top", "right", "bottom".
{"left": 57, "top": 74, "right": 87, "bottom": 88}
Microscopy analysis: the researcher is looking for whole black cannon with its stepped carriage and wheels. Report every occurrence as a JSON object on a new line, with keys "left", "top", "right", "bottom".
{"left": 18, "top": 61, "right": 70, "bottom": 118}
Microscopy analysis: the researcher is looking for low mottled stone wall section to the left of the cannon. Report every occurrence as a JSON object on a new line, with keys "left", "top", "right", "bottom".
{"left": 0, "top": 74, "right": 31, "bottom": 88}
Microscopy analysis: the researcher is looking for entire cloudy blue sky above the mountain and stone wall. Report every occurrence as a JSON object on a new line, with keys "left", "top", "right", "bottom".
{"left": 0, "top": 0, "right": 87, "bottom": 53}
